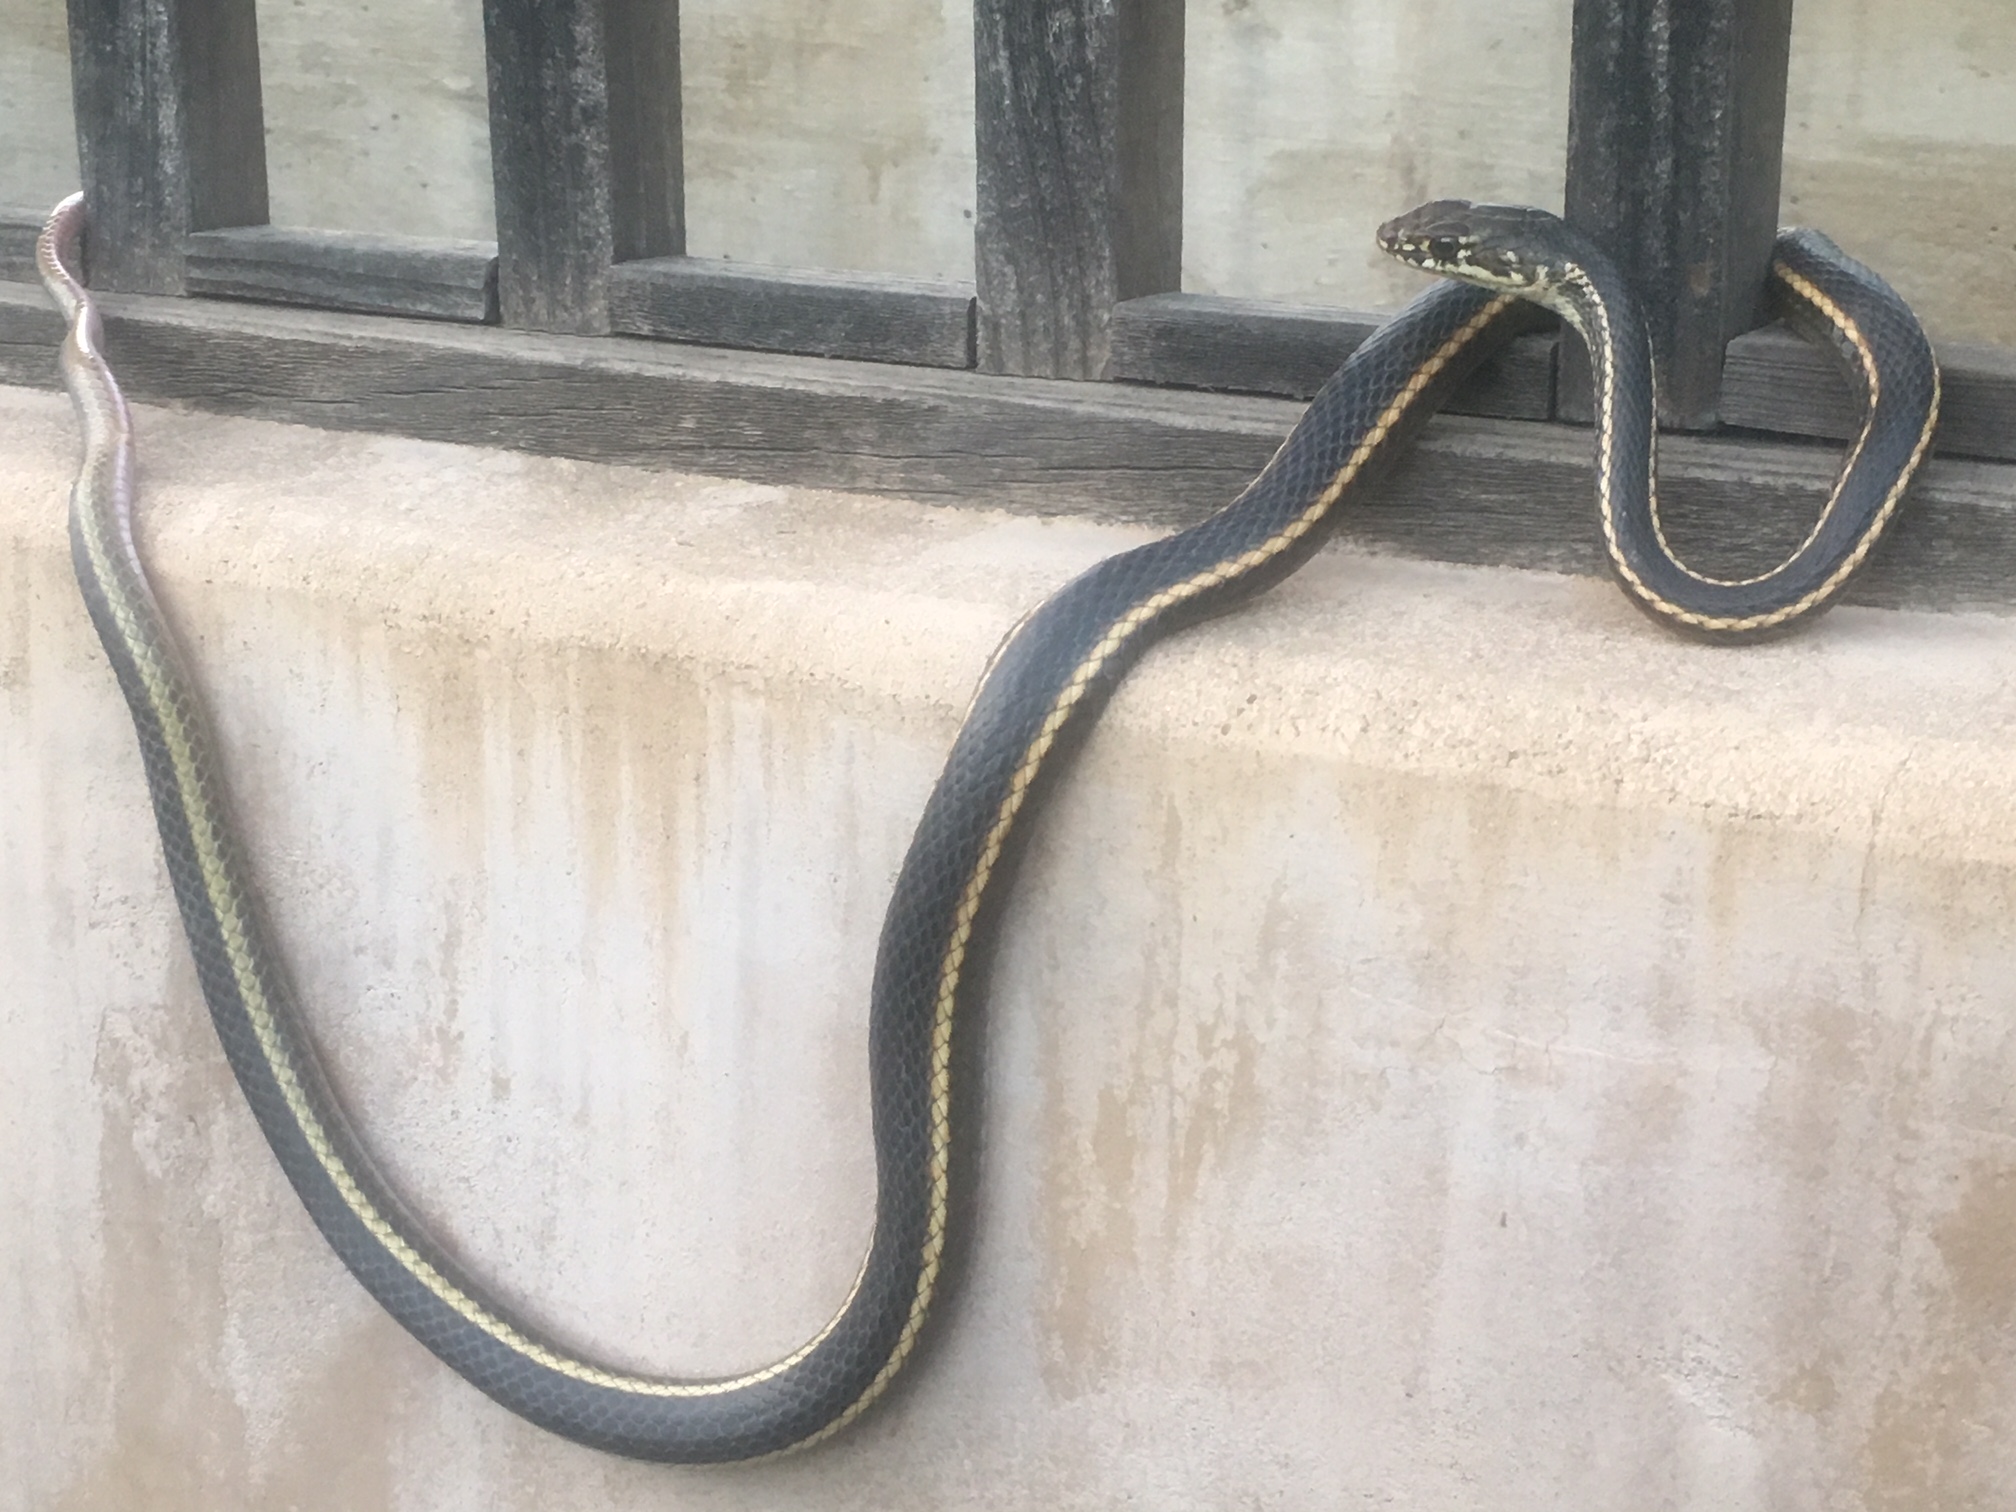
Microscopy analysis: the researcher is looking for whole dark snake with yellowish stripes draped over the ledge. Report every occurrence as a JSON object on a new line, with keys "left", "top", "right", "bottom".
{"left": 36, "top": 196, "right": 1937, "bottom": 1464}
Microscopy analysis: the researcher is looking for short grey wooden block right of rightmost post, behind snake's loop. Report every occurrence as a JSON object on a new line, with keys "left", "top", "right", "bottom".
{"left": 1722, "top": 325, "right": 2016, "bottom": 462}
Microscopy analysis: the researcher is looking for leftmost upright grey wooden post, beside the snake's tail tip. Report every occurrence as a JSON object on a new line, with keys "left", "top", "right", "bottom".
{"left": 69, "top": 0, "right": 266, "bottom": 294}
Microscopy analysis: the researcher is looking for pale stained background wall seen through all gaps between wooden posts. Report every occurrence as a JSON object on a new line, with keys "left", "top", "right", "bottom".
{"left": 0, "top": 0, "right": 2016, "bottom": 343}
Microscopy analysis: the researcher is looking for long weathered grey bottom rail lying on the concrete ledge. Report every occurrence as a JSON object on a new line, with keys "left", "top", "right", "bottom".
{"left": 0, "top": 284, "right": 2016, "bottom": 611}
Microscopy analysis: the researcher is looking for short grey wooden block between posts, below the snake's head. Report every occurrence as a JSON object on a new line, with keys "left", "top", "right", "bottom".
{"left": 1111, "top": 294, "right": 1554, "bottom": 419}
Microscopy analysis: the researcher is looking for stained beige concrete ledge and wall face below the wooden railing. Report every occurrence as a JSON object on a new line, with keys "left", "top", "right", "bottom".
{"left": 0, "top": 389, "right": 2016, "bottom": 1512}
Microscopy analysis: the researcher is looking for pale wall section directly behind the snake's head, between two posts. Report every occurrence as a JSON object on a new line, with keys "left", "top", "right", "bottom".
{"left": 1183, "top": 0, "right": 1570, "bottom": 308}
